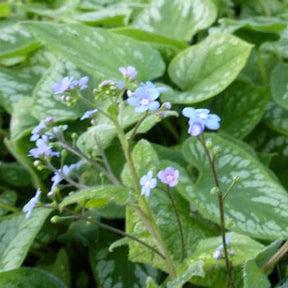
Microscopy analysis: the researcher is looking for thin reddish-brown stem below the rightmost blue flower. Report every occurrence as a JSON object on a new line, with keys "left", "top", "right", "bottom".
{"left": 198, "top": 134, "right": 236, "bottom": 288}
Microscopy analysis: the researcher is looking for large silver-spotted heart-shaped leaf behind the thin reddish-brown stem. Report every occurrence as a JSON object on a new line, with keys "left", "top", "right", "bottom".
{"left": 178, "top": 134, "right": 288, "bottom": 240}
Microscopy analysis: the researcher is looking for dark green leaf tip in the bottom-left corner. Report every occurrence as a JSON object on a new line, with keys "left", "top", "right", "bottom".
{"left": 0, "top": 268, "right": 67, "bottom": 288}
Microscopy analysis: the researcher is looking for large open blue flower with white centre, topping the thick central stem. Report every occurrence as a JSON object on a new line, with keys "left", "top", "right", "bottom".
{"left": 127, "top": 82, "right": 167, "bottom": 113}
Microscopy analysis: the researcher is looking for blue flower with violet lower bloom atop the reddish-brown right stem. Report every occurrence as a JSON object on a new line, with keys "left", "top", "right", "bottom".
{"left": 182, "top": 107, "right": 221, "bottom": 136}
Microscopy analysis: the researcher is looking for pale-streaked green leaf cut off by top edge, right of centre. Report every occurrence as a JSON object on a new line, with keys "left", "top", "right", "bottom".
{"left": 132, "top": 0, "right": 217, "bottom": 41}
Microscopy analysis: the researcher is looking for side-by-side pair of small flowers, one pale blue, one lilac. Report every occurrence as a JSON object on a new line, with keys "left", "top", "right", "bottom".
{"left": 140, "top": 167, "right": 179, "bottom": 197}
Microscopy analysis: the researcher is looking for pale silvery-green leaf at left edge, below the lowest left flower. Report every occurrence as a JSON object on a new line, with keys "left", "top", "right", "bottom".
{"left": 0, "top": 208, "right": 51, "bottom": 272}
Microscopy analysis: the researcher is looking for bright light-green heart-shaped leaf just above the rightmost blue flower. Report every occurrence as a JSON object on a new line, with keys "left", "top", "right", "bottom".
{"left": 165, "top": 34, "right": 252, "bottom": 104}
